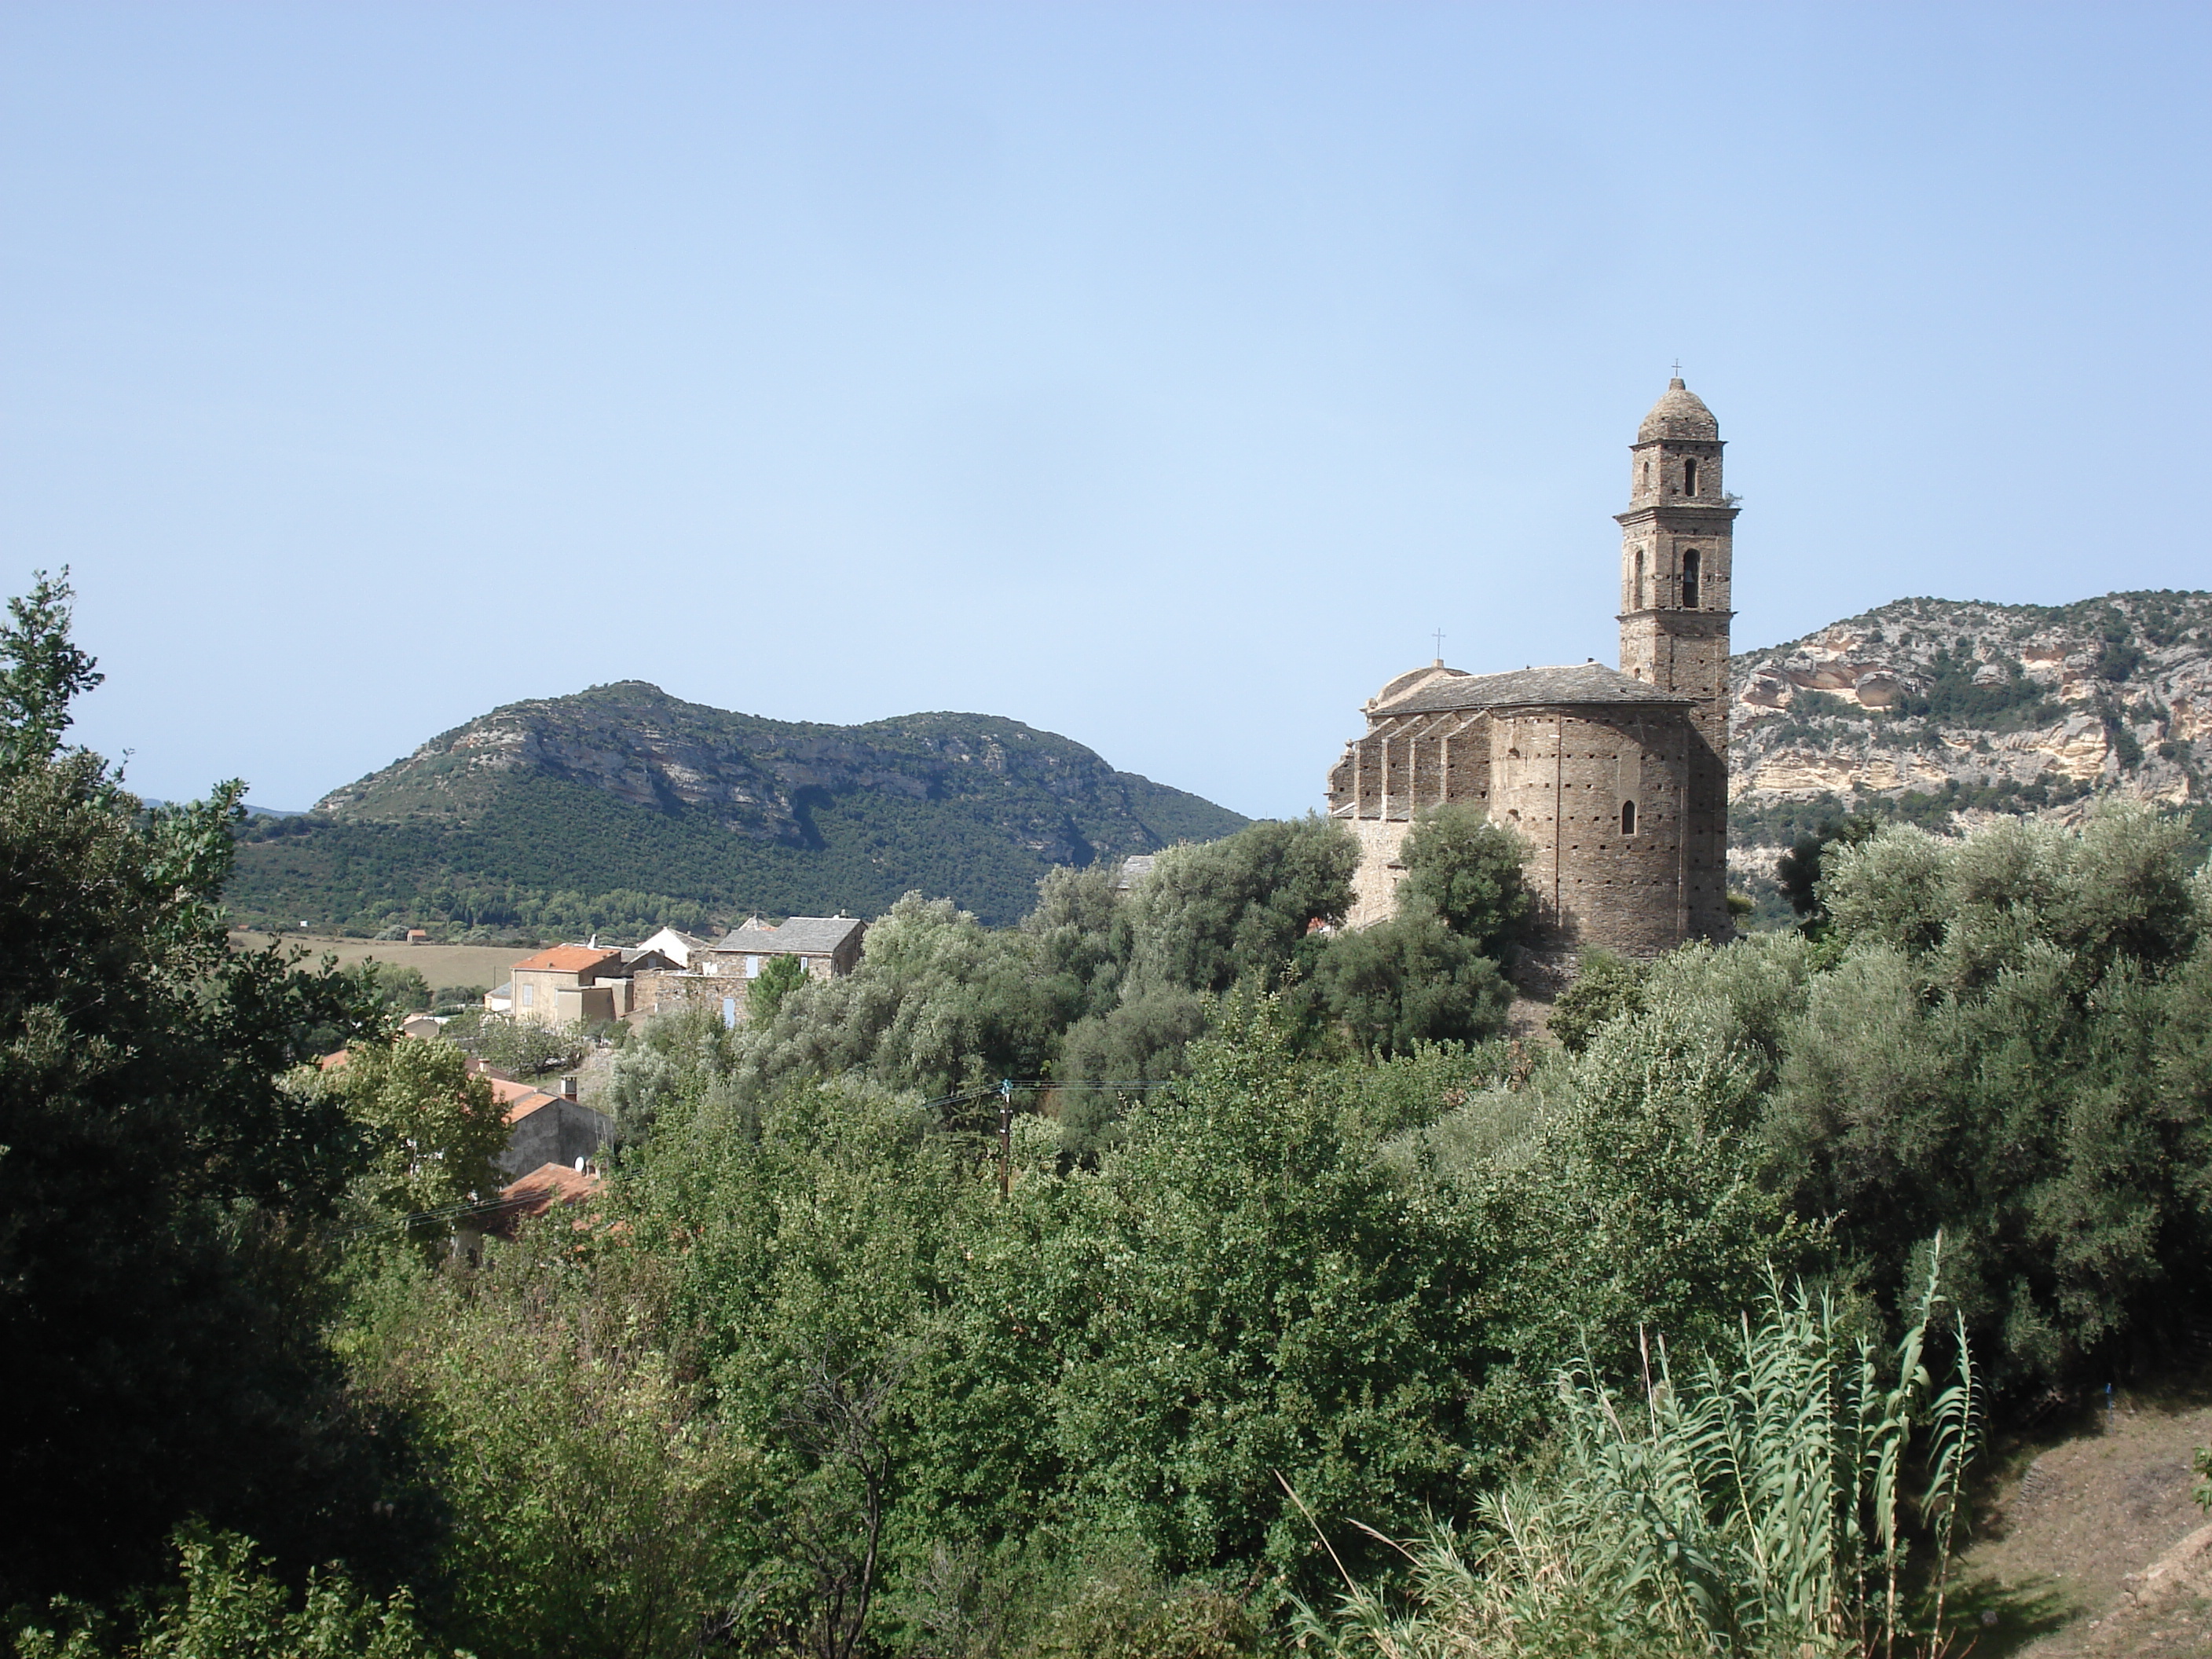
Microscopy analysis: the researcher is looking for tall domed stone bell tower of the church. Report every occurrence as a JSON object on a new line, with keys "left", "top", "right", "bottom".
{"left": 1615, "top": 376, "right": 1737, "bottom": 938}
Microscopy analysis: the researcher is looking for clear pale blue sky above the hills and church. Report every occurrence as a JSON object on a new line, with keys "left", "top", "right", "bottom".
{"left": 0, "top": 0, "right": 2212, "bottom": 814}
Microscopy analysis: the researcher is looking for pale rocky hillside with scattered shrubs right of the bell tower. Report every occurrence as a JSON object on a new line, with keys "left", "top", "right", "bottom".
{"left": 1730, "top": 593, "right": 2212, "bottom": 883}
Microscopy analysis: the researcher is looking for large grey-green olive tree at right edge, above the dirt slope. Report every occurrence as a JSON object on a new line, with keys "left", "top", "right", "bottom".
{"left": 1765, "top": 811, "right": 2212, "bottom": 1387}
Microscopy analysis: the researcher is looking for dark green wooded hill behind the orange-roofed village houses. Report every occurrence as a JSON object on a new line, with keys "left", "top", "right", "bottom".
{"left": 230, "top": 681, "right": 1245, "bottom": 936}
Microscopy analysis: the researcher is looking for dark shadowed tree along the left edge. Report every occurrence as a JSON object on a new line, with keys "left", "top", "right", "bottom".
{"left": 0, "top": 582, "right": 402, "bottom": 1602}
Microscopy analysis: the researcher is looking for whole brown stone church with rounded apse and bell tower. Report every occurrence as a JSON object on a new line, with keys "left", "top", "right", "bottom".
{"left": 1329, "top": 379, "right": 1737, "bottom": 956}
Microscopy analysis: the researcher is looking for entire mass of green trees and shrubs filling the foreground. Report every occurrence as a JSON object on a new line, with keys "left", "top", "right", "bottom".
{"left": 13, "top": 588, "right": 2212, "bottom": 1659}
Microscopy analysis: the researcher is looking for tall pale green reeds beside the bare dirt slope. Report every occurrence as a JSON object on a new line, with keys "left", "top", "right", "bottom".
{"left": 1298, "top": 1239, "right": 1979, "bottom": 1659}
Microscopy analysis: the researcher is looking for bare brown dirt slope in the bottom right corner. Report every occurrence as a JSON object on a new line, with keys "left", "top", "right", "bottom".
{"left": 1962, "top": 1389, "right": 2212, "bottom": 1659}
